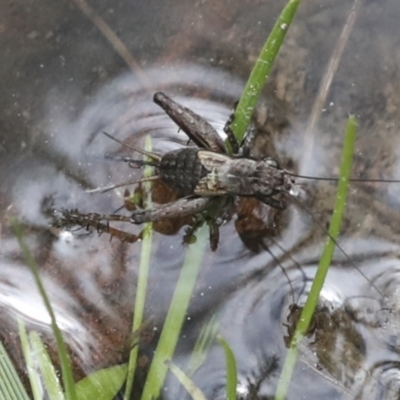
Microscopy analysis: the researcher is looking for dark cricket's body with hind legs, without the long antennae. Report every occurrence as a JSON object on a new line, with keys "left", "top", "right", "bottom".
{"left": 57, "top": 92, "right": 293, "bottom": 248}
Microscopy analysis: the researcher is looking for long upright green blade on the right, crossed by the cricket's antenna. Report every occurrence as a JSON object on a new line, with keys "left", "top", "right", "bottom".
{"left": 275, "top": 116, "right": 357, "bottom": 400}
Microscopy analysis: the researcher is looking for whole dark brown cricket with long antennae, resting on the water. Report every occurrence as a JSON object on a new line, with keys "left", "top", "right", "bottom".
{"left": 56, "top": 92, "right": 398, "bottom": 277}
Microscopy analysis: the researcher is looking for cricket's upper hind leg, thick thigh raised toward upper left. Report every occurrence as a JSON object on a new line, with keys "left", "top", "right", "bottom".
{"left": 153, "top": 92, "right": 226, "bottom": 153}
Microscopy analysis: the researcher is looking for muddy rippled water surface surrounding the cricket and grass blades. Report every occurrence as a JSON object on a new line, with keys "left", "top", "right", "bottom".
{"left": 0, "top": 0, "right": 400, "bottom": 399}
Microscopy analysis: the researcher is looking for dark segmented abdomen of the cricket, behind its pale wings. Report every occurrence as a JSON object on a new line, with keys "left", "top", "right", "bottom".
{"left": 159, "top": 148, "right": 207, "bottom": 196}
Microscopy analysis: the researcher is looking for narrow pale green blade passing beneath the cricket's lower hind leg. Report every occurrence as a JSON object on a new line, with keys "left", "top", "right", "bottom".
{"left": 124, "top": 136, "right": 153, "bottom": 400}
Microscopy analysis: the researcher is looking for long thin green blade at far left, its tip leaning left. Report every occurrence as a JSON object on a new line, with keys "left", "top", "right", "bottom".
{"left": 10, "top": 218, "right": 78, "bottom": 400}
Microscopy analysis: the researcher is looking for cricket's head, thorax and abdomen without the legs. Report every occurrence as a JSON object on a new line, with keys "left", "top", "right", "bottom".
{"left": 146, "top": 148, "right": 292, "bottom": 209}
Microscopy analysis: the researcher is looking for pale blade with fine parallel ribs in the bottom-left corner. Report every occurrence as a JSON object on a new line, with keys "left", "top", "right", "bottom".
{"left": 0, "top": 342, "right": 29, "bottom": 400}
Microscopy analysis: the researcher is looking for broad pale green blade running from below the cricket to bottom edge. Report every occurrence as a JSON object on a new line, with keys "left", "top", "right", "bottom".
{"left": 141, "top": 224, "right": 208, "bottom": 400}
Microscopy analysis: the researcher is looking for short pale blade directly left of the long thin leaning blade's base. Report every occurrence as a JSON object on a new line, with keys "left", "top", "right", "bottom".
{"left": 29, "top": 331, "right": 64, "bottom": 400}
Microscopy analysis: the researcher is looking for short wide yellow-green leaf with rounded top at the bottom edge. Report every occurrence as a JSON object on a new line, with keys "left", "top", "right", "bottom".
{"left": 76, "top": 364, "right": 127, "bottom": 400}
